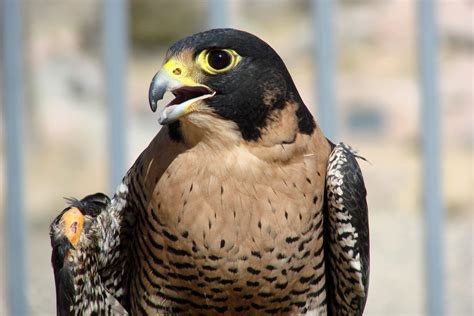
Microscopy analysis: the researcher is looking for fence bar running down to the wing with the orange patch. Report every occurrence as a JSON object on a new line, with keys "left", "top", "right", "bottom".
{"left": 103, "top": 0, "right": 128, "bottom": 192}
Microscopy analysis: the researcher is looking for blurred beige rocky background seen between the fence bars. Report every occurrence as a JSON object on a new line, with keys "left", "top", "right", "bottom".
{"left": 0, "top": 0, "right": 474, "bottom": 315}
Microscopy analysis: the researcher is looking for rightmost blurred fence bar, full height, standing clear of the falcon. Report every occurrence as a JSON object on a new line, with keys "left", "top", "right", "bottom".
{"left": 417, "top": 0, "right": 444, "bottom": 315}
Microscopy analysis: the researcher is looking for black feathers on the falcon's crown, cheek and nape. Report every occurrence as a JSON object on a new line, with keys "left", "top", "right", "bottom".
{"left": 167, "top": 29, "right": 315, "bottom": 140}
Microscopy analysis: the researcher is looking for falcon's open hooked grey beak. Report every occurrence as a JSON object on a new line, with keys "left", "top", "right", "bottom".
{"left": 148, "top": 69, "right": 216, "bottom": 125}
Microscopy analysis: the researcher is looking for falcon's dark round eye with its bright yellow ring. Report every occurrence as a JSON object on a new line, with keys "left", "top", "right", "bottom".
{"left": 198, "top": 49, "right": 241, "bottom": 75}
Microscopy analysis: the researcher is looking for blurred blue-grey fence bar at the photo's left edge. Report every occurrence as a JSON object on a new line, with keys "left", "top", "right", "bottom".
{"left": 2, "top": 0, "right": 28, "bottom": 315}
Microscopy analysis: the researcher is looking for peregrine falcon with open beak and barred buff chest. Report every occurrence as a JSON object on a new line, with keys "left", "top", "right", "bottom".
{"left": 50, "top": 29, "right": 369, "bottom": 315}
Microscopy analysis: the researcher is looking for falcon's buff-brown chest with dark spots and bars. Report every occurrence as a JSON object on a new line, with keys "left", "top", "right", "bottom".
{"left": 131, "top": 125, "right": 327, "bottom": 314}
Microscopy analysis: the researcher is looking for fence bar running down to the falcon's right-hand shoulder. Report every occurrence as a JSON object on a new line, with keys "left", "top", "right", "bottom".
{"left": 311, "top": 0, "right": 337, "bottom": 141}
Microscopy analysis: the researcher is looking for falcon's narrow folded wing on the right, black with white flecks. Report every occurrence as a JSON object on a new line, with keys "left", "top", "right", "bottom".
{"left": 325, "top": 143, "right": 369, "bottom": 315}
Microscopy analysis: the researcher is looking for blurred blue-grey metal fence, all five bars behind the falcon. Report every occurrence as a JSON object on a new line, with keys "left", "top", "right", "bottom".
{"left": 2, "top": 0, "right": 444, "bottom": 315}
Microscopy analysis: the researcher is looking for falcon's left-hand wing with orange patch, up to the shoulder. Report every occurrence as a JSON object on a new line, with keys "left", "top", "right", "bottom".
{"left": 50, "top": 127, "right": 186, "bottom": 315}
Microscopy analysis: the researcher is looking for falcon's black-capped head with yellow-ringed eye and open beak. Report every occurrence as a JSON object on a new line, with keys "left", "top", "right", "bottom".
{"left": 149, "top": 29, "right": 315, "bottom": 141}
